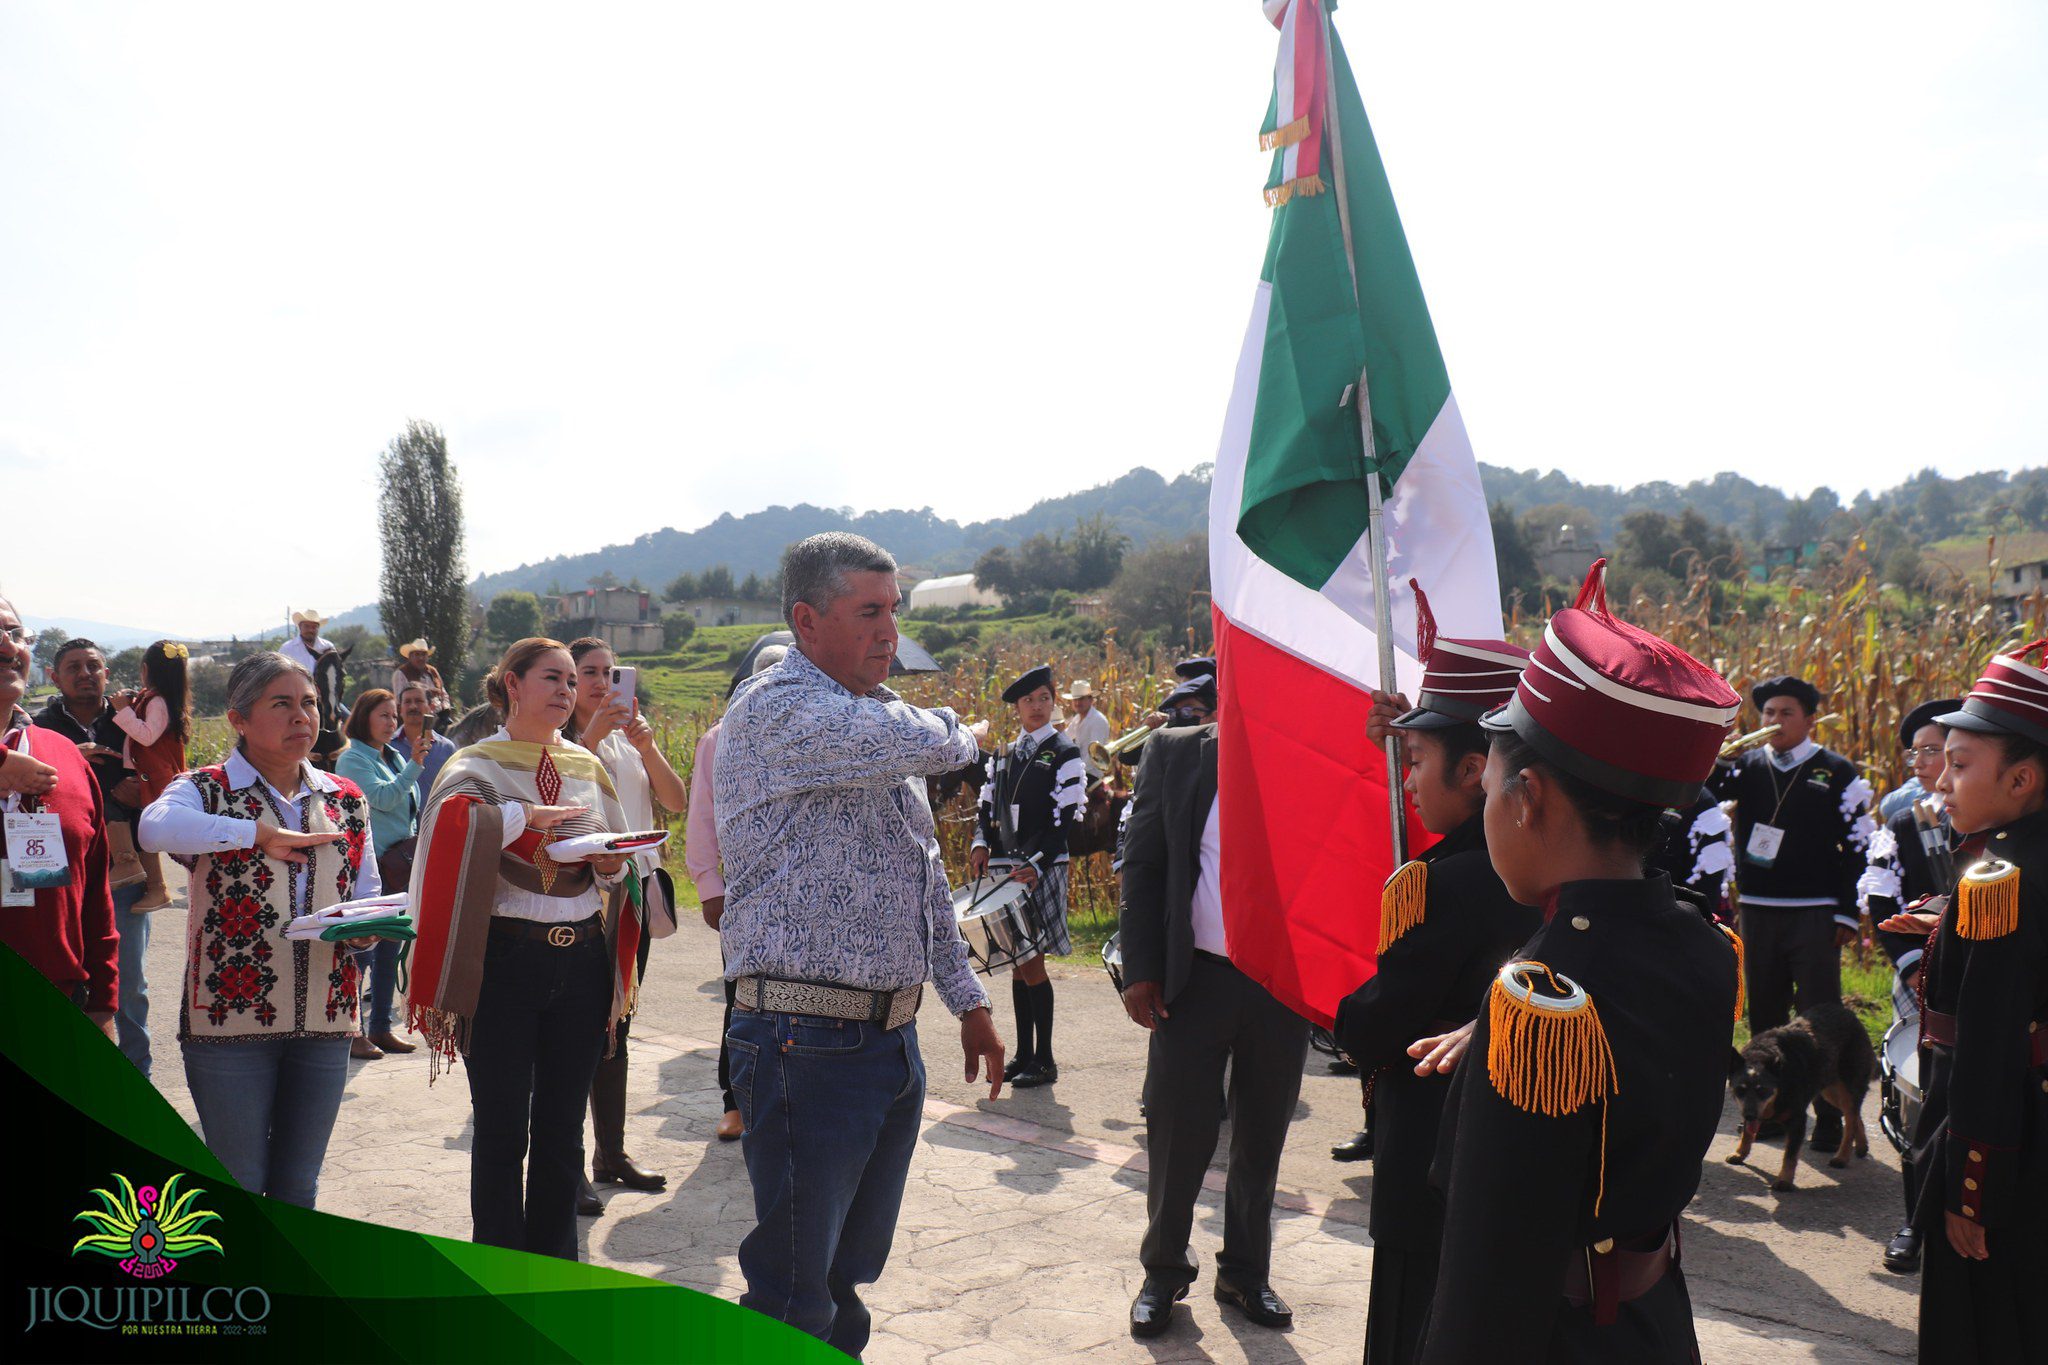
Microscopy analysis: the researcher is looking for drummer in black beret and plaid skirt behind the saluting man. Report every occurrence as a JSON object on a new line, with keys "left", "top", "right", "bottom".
{"left": 967, "top": 665, "right": 1087, "bottom": 1091}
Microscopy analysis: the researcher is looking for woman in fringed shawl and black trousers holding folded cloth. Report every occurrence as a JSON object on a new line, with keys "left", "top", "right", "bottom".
{"left": 395, "top": 639, "right": 639, "bottom": 1261}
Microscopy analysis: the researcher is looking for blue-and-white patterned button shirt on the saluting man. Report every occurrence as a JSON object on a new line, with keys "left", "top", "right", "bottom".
{"left": 711, "top": 649, "right": 989, "bottom": 1015}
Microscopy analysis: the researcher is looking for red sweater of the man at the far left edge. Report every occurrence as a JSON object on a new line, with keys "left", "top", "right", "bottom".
{"left": 0, "top": 722, "right": 121, "bottom": 1013}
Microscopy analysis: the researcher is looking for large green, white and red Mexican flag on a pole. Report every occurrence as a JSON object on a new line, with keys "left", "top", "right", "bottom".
{"left": 1208, "top": 0, "right": 1501, "bottom": 1023}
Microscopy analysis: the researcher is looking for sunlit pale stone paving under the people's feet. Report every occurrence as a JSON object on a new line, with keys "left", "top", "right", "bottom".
{"left": 150, "top": 871, "right": 1917, "bottom": 1365}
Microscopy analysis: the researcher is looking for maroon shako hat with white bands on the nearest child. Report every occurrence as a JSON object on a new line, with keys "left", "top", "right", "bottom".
{"left": 1483, "top": 559, "right": 1743, "bottom": 806}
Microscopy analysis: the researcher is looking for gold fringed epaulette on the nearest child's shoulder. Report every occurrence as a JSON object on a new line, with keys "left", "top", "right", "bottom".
{"left": 1487, "top": 962, "right": 1622, "bottom": 1218}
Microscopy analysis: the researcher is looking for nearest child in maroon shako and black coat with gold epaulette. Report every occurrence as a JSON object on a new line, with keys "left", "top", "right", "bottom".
{"left": 1411, "top": 561, "right": 1741, "bottom": 1365}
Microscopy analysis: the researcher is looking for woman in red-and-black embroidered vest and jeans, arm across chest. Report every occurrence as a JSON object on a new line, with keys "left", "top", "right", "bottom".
{"left": 137, "top": 653, "right": 381, "bottom": 1207}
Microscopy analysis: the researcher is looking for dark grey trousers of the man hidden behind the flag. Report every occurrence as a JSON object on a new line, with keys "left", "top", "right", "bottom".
{"left": 1139, "top": 954, "right": 1309, "bottom": 1289}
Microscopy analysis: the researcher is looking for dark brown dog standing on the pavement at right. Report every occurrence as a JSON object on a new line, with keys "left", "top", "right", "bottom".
{"left": 1729, "top": 1005, "right": 1878, "bottom": 1191}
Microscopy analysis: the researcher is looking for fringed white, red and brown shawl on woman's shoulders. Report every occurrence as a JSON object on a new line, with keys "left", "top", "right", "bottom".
{"left": 408, "top": 731, "right": 641, "bottom": 1078}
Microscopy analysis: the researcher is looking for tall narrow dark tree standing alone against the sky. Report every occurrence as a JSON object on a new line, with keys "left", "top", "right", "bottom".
{"left": 377, "top": 422, "right": 469, "bottom": 696}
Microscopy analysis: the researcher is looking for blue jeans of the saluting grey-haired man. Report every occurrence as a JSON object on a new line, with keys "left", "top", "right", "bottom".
{"left": 725, "top": 1009, "right": 924, "bottom": 1355}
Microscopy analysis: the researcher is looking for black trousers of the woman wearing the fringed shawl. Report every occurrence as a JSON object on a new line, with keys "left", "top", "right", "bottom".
{"left": 463, "top": 931, "right": 612, "bottom": 1261}
